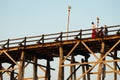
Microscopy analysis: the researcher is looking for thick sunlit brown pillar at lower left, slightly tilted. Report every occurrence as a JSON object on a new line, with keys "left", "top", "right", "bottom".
{"left": 18, "top": 51, "right": 25, "bottom": 80}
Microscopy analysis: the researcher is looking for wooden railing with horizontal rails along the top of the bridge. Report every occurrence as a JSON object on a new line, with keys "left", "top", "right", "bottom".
{"left": 0, "top": 25, "right": 120, "bottom": 49}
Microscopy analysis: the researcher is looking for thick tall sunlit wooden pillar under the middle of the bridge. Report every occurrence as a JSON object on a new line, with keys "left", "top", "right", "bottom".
{"left": 58, "top": 46, "right": 64, "bottom": 80}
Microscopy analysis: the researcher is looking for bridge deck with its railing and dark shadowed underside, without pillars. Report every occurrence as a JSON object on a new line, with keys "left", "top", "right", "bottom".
{"left": 0, "top": 26, "right": 120, "bottom": 63}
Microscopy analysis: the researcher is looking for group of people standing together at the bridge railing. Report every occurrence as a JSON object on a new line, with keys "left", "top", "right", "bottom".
{"left": 91, "top": 22, "right": 108, "bottom": 38}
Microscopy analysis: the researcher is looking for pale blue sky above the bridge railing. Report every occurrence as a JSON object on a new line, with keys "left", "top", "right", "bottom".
{"left": 0, "top": 0, "right": 120, "bottom": 79}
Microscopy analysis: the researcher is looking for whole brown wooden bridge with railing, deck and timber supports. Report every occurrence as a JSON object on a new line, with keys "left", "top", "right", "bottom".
{"left": 0, "top": 25, "right": 120, "bottom": 80}
